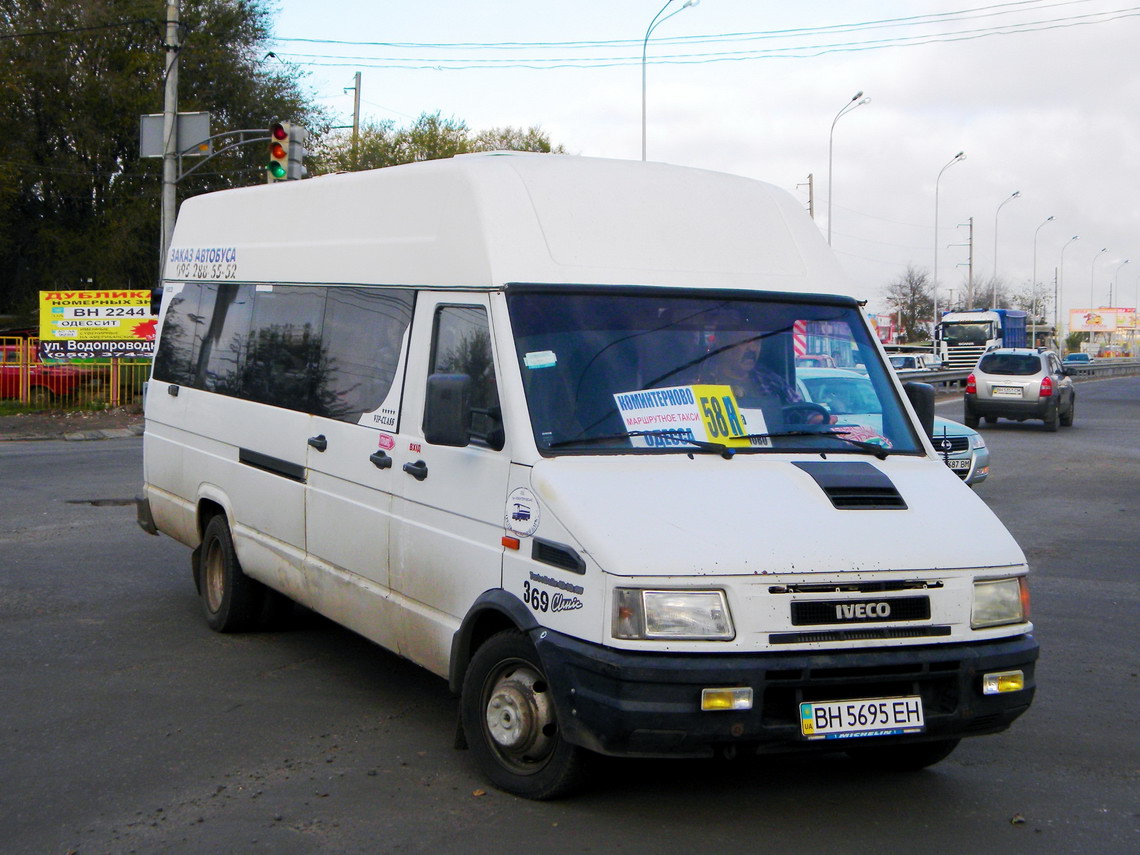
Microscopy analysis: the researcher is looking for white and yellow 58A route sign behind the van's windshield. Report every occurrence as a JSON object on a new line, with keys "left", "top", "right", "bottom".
{"left": 613, "top": 385, "right": 771, "bottom": 448}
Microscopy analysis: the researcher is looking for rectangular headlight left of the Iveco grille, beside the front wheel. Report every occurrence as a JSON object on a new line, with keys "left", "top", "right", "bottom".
{"left": 613, "top": 588, "right": 735, "bottom": 641}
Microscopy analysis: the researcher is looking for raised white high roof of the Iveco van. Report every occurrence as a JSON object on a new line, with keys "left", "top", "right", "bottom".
{"left": 166, "top": 152, "right": 862, "bottom": 296}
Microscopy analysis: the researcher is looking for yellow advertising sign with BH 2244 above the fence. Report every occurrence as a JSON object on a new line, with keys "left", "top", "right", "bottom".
{"left": 40, "top": 290, "right": 157, "bottom": 359}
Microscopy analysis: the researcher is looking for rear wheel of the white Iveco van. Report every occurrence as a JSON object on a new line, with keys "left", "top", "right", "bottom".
{"left": 200, "top": 514, "right": 266, "bottom": 633}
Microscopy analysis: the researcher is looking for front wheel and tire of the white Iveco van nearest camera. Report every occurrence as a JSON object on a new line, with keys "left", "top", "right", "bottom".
{"left": 459, "top": 629, "right": 586, "bottom": 800}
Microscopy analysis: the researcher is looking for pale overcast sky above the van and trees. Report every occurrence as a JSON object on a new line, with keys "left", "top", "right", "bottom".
{"left": 275, "top": 0, "right": 1140, "bottom": 319}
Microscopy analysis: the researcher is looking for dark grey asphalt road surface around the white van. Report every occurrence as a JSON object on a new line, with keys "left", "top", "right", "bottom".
{"left": 0, "top": 377, "right": 1140, "bottom": 855}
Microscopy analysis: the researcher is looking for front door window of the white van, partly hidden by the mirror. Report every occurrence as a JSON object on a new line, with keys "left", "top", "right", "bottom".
{"left": 430, "top": 306, "right": 505, "bottom": 450}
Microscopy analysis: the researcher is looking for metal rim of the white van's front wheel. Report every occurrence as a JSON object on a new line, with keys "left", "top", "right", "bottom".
{"left": 483, "top": 660, "right": 557, "bottom": 774}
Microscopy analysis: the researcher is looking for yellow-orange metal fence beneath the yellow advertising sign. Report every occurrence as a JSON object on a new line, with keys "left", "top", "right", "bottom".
{"left": 0, "top": 336, "right": 150, "bottom": 409}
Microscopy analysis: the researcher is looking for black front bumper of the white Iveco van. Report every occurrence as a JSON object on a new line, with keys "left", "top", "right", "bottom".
{"left": 531, "top": 629, "right": 1037, "bottom": 757}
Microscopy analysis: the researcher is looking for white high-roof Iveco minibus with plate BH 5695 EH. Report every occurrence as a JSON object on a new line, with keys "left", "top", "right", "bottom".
{"left": 138, "top": 154, "right": 1037, "bottom": 798}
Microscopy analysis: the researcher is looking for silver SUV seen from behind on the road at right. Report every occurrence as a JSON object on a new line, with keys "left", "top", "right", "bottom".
{"left": 962, "top": 348, "right": 1076, "bottom": 431}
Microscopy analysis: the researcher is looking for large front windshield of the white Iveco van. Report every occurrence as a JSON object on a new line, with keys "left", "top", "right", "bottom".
{"left": 507, "top": 286, "right": 921, "bottom": 455}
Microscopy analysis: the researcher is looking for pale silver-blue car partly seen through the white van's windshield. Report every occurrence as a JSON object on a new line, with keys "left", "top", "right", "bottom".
{"left": 796, "top": 368, "right": 990, "bottom": 487}
